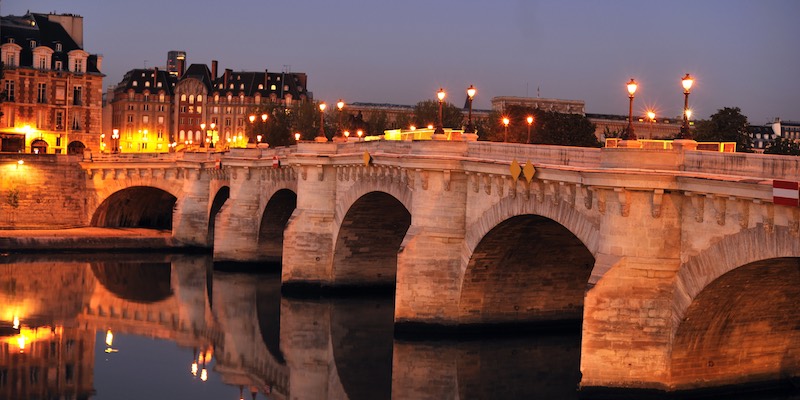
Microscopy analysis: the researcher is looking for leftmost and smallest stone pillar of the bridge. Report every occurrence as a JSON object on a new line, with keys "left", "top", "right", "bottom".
{"left": 172, "top": 168, "right": 210, "bottom": 247}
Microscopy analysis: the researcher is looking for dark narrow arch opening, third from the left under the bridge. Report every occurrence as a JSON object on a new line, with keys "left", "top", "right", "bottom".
{"left": 258, "top": 189, "right": 297, "bottom": 262}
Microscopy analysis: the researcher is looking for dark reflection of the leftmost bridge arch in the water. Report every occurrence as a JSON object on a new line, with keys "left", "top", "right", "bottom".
{"left": 92, "top": 262, "right": 172, "bottom": 304}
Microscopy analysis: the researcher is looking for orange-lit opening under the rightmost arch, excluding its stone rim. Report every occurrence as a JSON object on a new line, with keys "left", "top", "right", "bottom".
{"left": 671, "top": 258, "right": 800, "bottom": 389}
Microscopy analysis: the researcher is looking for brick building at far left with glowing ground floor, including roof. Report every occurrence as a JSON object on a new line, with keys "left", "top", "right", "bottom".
{"left": 0, "top": 13, "right": 104, "bottom": 154}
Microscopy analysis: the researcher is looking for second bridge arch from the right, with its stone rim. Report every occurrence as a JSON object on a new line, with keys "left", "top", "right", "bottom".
{"left": 459, "top": 196, "right": 599, "bottom": 325}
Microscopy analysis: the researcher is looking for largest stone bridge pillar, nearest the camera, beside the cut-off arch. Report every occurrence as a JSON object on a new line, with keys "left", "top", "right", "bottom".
{"left": 581, "top": 189, "right": 682, "bottom": 389}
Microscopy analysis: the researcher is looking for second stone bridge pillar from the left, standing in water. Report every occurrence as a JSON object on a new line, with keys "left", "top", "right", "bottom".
{"left": 212, "top": 166, "right": 262, "bottom": 262}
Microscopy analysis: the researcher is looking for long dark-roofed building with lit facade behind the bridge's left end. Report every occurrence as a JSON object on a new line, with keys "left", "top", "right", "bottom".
{"left": 106, "top": 52, "right": 311, "bottom": 152}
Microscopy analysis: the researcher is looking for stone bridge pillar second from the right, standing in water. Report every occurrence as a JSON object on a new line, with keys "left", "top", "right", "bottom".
{"left": 395, "top": 169, "right": 467, "bottom": 329}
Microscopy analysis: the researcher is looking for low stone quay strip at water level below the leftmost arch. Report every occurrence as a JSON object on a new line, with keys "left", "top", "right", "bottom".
{"left": 0, "top": 227, "right": 185, "bottom": 252}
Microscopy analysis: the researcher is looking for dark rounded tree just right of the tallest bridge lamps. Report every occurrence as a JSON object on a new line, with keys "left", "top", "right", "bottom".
{"left": 694, "top": 107, "right": 753, "bottom": 152}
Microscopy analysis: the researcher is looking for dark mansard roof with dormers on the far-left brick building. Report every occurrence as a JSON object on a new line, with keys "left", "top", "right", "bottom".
{"left": 0, "top": 13, "right": 100, "bottom": 73}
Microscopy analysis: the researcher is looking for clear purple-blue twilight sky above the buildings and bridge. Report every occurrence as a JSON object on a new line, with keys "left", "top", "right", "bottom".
{"left": 0, "top": 0, "right": 800, "bottom": 124}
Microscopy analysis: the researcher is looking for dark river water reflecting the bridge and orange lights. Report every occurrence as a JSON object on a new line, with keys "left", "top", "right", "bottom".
{"left": 0, "top": 254, "right": 580, "bottom": 399}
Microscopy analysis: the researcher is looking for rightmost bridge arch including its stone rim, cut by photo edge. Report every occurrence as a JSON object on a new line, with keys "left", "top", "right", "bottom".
{"left": 670, "top": 226, "right": 800, "bottom": 389}
